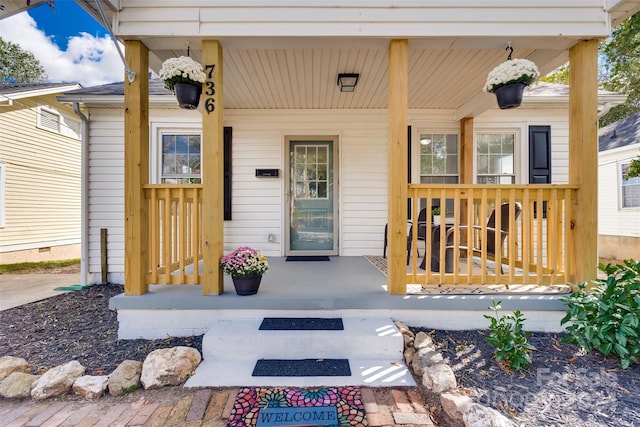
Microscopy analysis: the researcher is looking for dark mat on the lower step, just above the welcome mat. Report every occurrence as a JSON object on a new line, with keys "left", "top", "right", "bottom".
{"left": 251, "top": 359, "right": 351, "bottom": 377}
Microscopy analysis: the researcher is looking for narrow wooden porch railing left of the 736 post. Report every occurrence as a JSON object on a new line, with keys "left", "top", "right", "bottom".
{"left": 144, "top": 184, "right": 202, "bottom": 285}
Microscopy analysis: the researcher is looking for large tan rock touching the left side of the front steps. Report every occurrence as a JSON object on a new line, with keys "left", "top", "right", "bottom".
{"left": 140, "top": 347, "right": 202, "bottom": 389}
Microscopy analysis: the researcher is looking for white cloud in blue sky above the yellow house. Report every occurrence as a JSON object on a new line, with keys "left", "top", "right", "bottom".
{"left": 0, "top": 12, "right": 124, "bottom": 87}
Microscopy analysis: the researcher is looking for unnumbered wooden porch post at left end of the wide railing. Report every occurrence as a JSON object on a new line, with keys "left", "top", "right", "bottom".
{"left": 387, "top": 39, "right": 409, "bottom": 295}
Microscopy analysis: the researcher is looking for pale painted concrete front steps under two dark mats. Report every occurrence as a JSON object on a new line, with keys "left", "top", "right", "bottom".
{"left": 185, "top": 315, "right": 415, "bottom": 387}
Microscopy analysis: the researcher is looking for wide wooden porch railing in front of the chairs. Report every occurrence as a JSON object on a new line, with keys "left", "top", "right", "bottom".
{"left": 406, "top": 184, "right": 577, "bottom": 285}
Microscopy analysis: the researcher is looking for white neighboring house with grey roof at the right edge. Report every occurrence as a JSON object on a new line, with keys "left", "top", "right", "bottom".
{"left": 598, "top": 113, "right": 640, "bottom": 260}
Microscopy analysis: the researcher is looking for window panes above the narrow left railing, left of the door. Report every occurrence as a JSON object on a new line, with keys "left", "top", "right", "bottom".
{"left": 160, "top": 132, "right": 202, "bottom": 184}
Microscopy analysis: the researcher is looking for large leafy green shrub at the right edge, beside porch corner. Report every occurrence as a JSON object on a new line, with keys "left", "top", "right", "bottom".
{"left": 560, "top": 260, "right": 640, "bottom": 368}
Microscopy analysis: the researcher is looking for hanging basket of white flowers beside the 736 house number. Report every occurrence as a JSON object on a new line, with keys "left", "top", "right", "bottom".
{"left": 158, "top": 56, "right": 207, "bottom": 110}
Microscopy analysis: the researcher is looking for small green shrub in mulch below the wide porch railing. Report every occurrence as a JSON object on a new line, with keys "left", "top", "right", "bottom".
{"left": 484, "top": 301, "right": 536, "bottom": 371}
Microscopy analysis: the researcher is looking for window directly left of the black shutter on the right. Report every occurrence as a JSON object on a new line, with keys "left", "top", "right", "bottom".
{"left": 476, "top": 132, "right": 516, "bottom": 184}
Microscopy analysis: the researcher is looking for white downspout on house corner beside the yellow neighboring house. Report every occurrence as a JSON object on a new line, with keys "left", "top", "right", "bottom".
{"left": 73, "top": 102, "right": 89, "bottom": 286}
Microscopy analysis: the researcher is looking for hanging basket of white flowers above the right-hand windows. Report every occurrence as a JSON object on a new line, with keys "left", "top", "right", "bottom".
{"left": 484, "top": 59, "right": 540, "bottom": 110}
